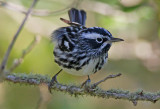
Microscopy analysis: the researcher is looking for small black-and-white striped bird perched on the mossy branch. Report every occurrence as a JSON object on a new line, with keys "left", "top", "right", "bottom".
{"left": 49, "top": 8, "right": 124, "bottom": 89}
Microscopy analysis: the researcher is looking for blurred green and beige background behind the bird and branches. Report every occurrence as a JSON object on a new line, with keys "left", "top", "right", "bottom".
{"left": 0, "top": 0, "right": 160, "bottom": 109}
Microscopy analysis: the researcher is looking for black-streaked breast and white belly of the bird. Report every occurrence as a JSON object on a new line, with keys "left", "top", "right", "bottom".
{"left": 54, "top": 46, "right": 107, "bottom": 76}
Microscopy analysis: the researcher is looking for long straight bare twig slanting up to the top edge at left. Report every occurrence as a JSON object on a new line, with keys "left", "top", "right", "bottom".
{"left": 0, "top": 0, "right": 38, "bottom": 73}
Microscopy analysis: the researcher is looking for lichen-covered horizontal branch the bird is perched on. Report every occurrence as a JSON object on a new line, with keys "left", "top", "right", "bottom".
{"left": 5, "top": 73, "right": 160, "bottom": 105}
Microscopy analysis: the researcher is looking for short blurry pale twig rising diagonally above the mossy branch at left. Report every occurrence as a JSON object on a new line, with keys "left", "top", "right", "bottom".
{"left": 9, "top": 36, "right": 40, "bottom": 72}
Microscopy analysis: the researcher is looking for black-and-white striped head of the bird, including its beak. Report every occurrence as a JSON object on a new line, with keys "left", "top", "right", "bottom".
{"left": 79, "top": 27, "right": 124, "bottom": 55}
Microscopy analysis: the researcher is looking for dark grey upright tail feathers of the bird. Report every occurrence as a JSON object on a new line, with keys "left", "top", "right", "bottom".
{"left": 68, "top": 8, "right": 86, "bottom": 26}
